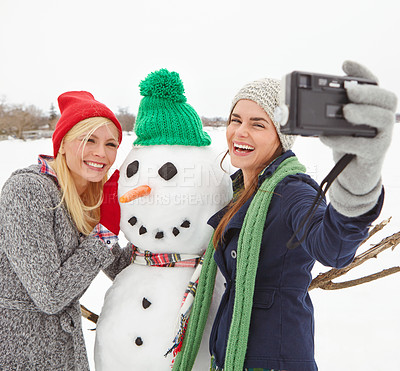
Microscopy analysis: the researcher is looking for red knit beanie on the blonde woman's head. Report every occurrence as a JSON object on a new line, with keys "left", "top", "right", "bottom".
{"left": 53, "top": 91, "right": 122, "bottom": 158}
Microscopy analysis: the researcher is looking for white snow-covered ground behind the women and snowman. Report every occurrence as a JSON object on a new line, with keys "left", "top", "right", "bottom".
{"left": 0, "top": 124, "right": 400, "bottom": 371}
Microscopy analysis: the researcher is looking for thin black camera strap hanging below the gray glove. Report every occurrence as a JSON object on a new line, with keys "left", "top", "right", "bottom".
{"left": 286, "top": 153, "right": 356, "bottom": 249}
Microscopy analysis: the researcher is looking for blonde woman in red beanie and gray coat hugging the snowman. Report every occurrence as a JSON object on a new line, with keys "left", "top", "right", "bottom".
{"left": 0, "top": 91, "right": 130, "bottom": 370}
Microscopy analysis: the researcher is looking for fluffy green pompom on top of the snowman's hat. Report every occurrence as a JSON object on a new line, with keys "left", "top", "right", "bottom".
{"left": 139, "top": 68, "right": 186, "bottom": 103}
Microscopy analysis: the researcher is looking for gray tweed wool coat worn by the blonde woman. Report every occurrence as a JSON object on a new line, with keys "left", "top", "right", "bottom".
{"left": 0, "top": 165, "right": 130, "bottom": 370}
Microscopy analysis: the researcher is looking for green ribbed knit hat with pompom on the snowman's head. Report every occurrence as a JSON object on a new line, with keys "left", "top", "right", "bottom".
{"left": 133, "top": 69, "right": 211, "bottom": 147}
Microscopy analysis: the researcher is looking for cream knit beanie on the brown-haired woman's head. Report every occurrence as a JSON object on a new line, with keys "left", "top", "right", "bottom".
{"left": 231, "top": 78, "right": 296, "bottom": 152}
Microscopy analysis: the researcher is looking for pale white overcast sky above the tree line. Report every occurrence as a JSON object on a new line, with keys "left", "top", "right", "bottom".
{"left": 0, "top": 0, "right": 400, "bottom": 117}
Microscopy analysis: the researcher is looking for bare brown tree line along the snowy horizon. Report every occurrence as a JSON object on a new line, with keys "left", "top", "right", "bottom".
{"left": 0, "top": 100, "right": 226, "bottom": 139}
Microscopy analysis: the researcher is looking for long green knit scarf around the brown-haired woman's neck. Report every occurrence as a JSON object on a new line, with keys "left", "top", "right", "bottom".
{"left": 173, "top": 156, "right": 306, "bottom": 371}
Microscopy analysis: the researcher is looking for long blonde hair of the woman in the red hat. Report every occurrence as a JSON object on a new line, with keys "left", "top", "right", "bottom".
{"left": 49, "top": 117, "right": 119, "bottom": 235}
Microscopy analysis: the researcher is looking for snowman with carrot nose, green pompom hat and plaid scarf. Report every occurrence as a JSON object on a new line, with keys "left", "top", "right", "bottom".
{"left": 95, "top": 69, "right": 232, "bottom": 371}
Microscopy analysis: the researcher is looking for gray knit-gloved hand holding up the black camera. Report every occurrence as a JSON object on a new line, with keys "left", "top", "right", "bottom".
{"left": 320, "top": 61, "right": 397, "bottom": 217}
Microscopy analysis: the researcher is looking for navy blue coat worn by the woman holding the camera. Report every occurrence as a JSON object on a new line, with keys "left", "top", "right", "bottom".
{"left": 209, "top": 151, "right": 383, "bottom": 371}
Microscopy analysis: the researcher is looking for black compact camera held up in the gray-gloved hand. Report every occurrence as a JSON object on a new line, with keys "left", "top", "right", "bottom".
{"left": 275, "top": 71, "right": 377, "bottom": 137}
